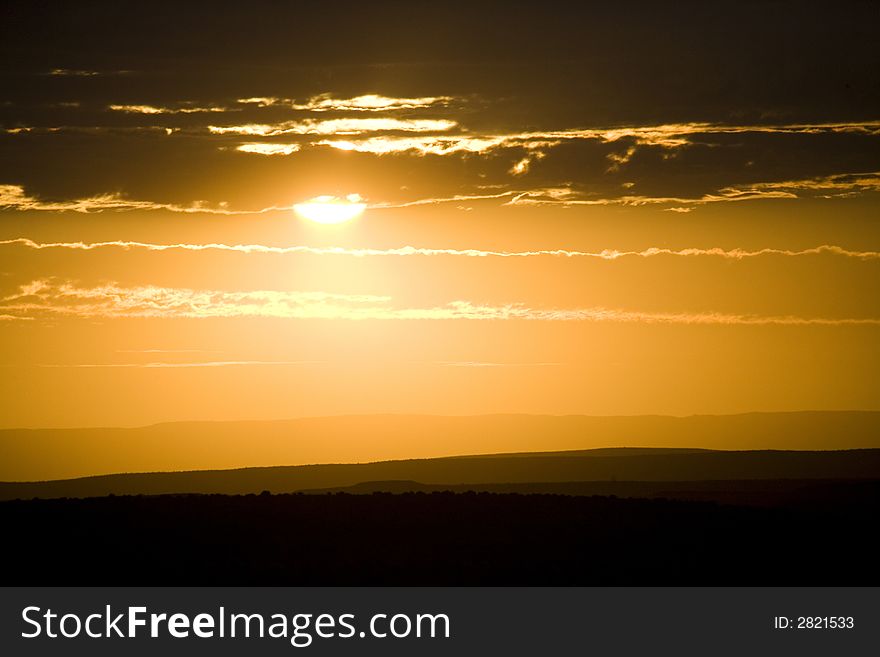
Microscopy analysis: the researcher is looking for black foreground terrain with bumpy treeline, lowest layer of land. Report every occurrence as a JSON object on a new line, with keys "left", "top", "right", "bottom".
{"left": 0, "top": 480, "right": 880, "bottom": 585}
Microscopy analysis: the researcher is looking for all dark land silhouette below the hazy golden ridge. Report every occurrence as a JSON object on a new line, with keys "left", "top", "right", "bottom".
{"left": 0, "top": 413, "right": 880, "bottom": 585}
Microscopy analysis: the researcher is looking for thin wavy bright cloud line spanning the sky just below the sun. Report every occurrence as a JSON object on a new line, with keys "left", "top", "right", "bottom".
{"left": 0, "top": 237, "right": 880, "bottom": 260}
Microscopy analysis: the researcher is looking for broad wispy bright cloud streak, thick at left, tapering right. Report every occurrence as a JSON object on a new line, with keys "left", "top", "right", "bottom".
{"left": 0, "top": 280, "right": 880, "bottom": 326}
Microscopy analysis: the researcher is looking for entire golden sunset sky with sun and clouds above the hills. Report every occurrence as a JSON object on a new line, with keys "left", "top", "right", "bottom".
{"left": 0, "top": 0, "right": 880, "bottom": 427}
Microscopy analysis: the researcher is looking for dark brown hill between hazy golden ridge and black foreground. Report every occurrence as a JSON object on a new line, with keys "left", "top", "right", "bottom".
{"left": 0, "top": 448, "right": 880, "bottom": 501}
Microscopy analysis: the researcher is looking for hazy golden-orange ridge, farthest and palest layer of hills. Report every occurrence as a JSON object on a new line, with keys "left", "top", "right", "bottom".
{"left": 0, "top": 412, "right": 880, "bottom": 486}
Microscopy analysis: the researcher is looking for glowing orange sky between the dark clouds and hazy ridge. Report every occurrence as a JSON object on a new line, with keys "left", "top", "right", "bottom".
{"left": 0, "top": 192, "right": 880, "bottom": 426}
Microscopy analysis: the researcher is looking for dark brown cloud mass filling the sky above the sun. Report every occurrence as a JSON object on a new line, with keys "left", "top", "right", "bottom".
{"left": 0, "top": 1, "right": 880, "bottom": 207}
